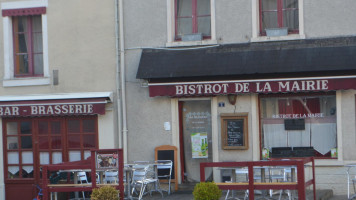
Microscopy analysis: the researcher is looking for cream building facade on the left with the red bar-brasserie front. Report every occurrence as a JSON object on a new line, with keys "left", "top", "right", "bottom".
{"left": 0, "top": 0, "right": 119, "bottom": 199}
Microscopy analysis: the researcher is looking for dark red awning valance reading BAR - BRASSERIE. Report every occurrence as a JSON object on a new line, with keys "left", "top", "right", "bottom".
{"left": 0, "top": 103, "right": 105, "bottom": 117}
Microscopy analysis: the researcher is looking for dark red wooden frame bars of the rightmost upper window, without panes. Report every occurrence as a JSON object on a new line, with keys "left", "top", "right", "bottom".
{"left": 259, "top": 0, "right": 299, "bottom": 36}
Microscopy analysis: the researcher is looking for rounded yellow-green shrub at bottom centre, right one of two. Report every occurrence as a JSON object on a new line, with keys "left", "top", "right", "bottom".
{"left": 193, "top": 182, "right": 222, "bottom": 200}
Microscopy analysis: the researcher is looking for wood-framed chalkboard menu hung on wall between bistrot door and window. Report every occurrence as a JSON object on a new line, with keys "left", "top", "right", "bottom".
{"left": 221, "top": 116, "right": 248, "bottom": 149}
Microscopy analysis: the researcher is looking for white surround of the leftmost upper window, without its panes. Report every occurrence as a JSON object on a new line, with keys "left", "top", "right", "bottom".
{"left": 1, "top": 0, "right": 50, "bottom": 87}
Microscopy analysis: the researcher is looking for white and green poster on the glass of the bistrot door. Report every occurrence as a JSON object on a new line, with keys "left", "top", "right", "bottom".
{"left": 191, "top": 133, "right": 208, "bottom": 158}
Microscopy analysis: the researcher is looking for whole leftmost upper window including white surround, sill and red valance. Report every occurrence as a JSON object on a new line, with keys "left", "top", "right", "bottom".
{"left": 1, "top": 0, "right": 50, "bottom": 87}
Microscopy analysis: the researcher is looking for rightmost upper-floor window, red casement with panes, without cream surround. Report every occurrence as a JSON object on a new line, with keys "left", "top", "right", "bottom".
{"left": 259, "top": 0, "right": 299, "bottom": 35}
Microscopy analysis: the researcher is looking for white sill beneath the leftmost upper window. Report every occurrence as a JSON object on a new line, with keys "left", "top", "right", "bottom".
{"left": 2, "top": 77, "right": 51, "bottom": 87}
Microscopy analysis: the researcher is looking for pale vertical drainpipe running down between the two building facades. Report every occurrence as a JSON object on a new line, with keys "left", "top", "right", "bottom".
{"left": 116, "top": 0, "right": 128, "bottom": 162}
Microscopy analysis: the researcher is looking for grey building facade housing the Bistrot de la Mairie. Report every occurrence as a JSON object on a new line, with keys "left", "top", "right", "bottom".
{"left": 123, "top": 0, "right": 356, "bottom": 194}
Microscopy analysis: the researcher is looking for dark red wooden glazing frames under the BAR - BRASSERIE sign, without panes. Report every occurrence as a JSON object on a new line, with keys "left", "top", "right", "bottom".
{"left": 3, "top": 115, "right": 99, "bottom": 183}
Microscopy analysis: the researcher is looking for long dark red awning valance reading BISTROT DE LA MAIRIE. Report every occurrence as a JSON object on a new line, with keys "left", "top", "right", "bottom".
{"left": 149, "top": 78, "right": 356, "bottom": 97}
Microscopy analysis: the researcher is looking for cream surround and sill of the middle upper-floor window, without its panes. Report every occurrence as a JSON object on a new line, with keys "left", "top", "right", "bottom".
{"left": 166, "top": 0, "right": 217, "bottom": 47}
